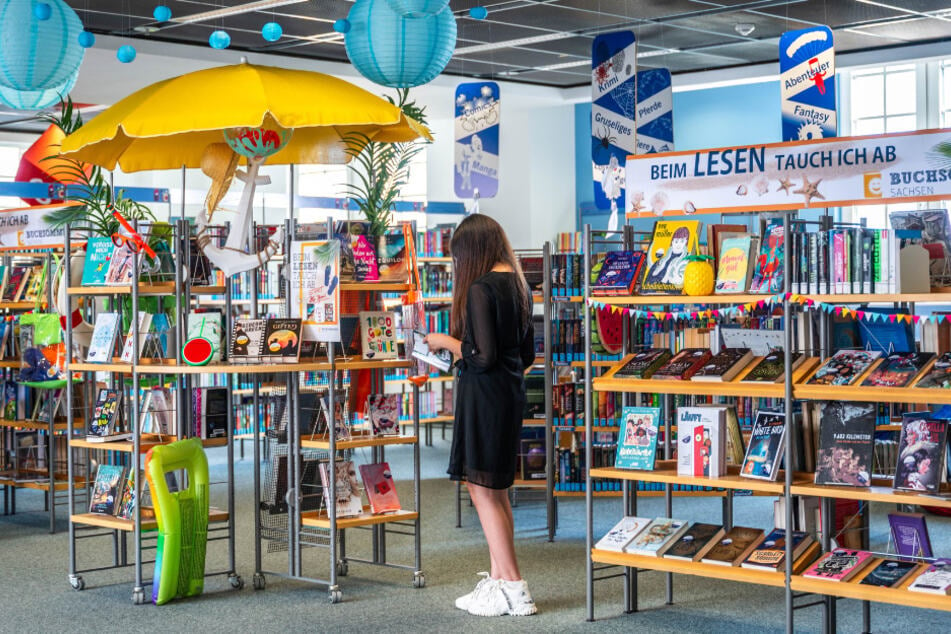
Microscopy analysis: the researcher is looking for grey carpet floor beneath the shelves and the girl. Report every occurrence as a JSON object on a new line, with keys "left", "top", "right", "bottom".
{"left": 0, "top": 433, "right": 951, "bottom": 634}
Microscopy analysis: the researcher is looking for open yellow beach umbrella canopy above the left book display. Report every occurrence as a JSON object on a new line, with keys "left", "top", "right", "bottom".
{"left": 62, "top": 63, "right": 431, "bottom": 172}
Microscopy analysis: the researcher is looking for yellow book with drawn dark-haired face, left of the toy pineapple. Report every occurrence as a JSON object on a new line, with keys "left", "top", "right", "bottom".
{"left": 641, "top": 220, "right": 700, "bottom": 294}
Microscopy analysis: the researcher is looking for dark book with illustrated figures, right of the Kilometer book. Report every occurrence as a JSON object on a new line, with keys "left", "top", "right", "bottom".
{"left": 894, "top": 412, "right": 948, "bottom": 493}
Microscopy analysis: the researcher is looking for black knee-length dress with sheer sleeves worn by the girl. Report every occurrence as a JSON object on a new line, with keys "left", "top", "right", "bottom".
{"left": 448, "top": 271, "right": 535, "bottom": 489}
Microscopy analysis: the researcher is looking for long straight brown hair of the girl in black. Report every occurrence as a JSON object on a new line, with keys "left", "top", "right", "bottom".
{"left": 449, "top": 214, "right": 532, "bottom": 339}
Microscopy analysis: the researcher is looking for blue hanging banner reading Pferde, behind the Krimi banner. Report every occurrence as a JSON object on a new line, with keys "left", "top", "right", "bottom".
{"left": 634, "top": 68, "right": 674, "bottom": 154}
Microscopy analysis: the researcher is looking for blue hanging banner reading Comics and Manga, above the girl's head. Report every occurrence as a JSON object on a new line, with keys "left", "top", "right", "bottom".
{"left": 455, "top": 81, "right": 499, "bottom": 199}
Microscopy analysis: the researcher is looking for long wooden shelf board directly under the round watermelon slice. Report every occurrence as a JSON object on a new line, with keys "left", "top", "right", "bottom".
{"left": 69, "top": 358, "right": 411, "bottom": 374}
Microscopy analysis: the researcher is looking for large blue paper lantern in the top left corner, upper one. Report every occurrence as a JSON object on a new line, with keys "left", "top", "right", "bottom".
{"left": 0, "top": 0, "right": 85, "bottom": 91}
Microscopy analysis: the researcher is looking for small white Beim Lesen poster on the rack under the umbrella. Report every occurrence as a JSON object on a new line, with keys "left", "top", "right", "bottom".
{"left": 290, "top": 240, "right": 340, "bottom": 341}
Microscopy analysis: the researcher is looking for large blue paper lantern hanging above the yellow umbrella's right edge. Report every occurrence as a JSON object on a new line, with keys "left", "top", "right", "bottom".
{"left": 345, "top": 0, "right": 456, "bottom": 88}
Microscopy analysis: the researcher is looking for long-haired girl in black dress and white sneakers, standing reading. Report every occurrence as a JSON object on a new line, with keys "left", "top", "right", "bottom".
{"left": 425, "top": 214, "right": 536, "bottom": 616}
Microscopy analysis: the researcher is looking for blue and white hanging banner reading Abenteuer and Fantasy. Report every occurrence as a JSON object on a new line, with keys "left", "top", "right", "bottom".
{"left": 779, "top": 26, "right": 837, "bottom": 141}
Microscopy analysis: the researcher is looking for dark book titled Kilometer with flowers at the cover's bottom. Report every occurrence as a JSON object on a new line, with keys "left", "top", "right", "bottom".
{"left": 815, "top": 401, "right": 878, "bottom": 487}
